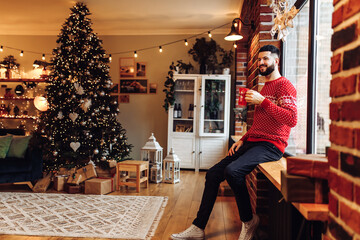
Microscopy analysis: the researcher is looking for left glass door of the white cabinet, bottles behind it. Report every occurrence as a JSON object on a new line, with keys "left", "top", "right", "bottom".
{"left": 170, "top": 77, "right": 196, "bottom": 134}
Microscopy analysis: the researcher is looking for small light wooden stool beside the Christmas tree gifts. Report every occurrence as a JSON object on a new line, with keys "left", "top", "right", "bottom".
{"left": 116, "top": 160, "right": 149, "bottom": 192}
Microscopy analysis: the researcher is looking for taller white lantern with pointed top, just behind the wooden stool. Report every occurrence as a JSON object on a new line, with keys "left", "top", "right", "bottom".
{"left": 141, "top": 133, "right": 163, "bottom": 183}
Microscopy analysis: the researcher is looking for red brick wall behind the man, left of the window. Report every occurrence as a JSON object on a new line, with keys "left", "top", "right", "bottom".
{"left": 236, "top": 0, "right": 280, "bottom": 231}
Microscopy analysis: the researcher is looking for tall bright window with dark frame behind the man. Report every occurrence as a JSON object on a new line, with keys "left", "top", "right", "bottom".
{"left": 283, "top": 0, "right": 333, "bottom": 155}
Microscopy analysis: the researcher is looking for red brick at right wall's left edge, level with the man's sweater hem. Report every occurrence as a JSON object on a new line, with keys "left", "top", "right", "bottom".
{"left": 330, "top": 124, "right": 354, "bottom": 148}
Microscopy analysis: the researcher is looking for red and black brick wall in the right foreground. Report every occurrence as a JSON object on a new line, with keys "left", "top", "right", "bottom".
{"left": 324, "top": 0, "right": 360, "bottom": 240}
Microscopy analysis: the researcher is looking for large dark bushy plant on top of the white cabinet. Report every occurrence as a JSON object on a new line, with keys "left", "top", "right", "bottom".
{"left": 188, "top": 38, "right": 221, "bottom": 74}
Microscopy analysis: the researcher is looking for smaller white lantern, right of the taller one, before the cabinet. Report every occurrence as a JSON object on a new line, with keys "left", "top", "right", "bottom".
{"left": 164, "top": 148, "right": 180, "bottom": 183}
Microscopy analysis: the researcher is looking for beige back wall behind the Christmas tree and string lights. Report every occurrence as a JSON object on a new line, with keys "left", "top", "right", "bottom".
{"left": 0, "top": 35, "right": 233, "bottom": 159}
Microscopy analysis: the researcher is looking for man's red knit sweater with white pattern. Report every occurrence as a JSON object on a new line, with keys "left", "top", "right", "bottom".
{"left": 241, "top": 77, "right": 297, "bottom": 152}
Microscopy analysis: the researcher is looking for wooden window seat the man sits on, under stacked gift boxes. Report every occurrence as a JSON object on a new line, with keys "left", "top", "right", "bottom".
{"left": 258, "top": 158, "right": 328, "bottom": 221}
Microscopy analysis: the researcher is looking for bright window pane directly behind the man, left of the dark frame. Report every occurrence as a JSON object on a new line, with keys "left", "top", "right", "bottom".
{"left": 284, "top": 2, "right": 309, "bottom": 154}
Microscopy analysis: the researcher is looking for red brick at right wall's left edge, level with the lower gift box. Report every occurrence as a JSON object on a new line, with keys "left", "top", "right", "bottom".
{"left": 329, "top": 171, "right": 353, "bottom": 201}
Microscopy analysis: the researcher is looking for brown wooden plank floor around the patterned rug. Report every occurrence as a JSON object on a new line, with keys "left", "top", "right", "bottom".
{"left": 0, "top": 171, "right": 241, "bottom": 240}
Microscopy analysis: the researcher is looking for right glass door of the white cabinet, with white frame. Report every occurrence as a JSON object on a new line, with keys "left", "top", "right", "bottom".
{"left": 199, "top": 76, "right": 228, "bottom": 136}
